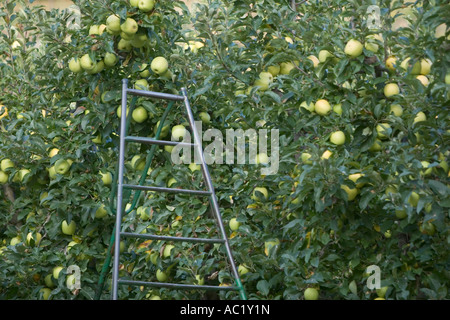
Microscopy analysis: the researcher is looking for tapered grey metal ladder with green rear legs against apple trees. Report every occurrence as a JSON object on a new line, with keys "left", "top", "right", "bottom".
{"left": 104, "top": 79, "right": 247, "bottom": 300}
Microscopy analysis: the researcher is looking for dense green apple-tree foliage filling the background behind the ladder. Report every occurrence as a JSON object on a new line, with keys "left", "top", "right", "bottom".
{"left": 0, "top": 0, "right": 450, "bottom": 299}
